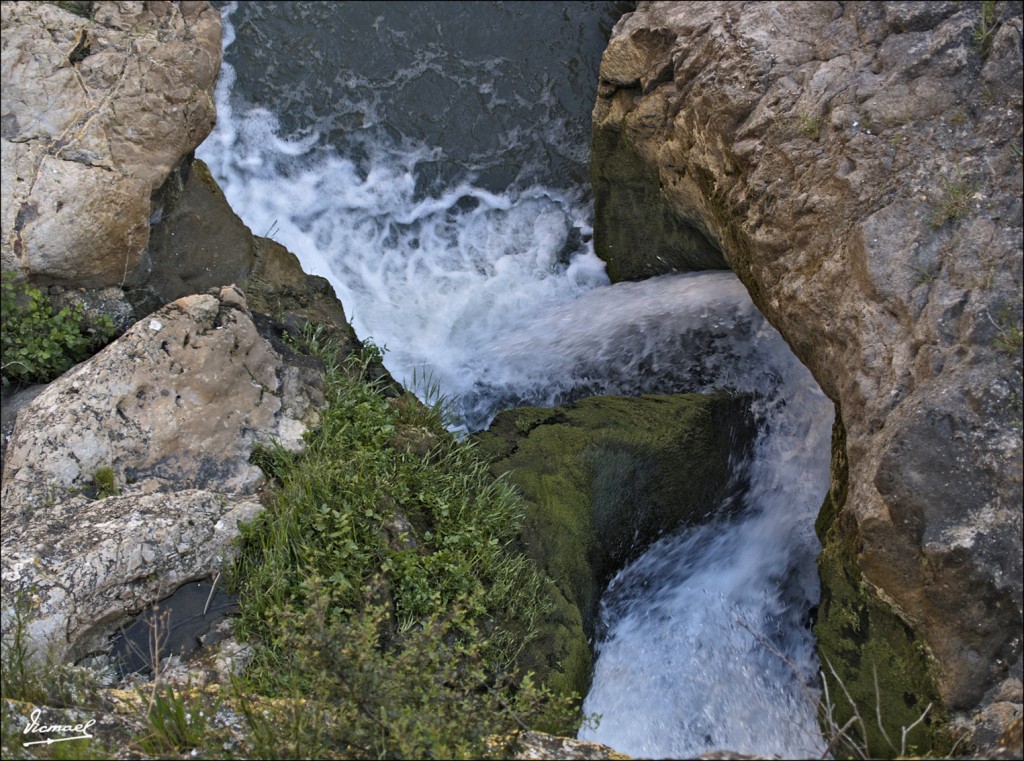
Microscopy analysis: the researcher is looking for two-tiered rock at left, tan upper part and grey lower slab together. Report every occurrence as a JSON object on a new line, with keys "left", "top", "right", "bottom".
{"left": 0, "top": 287, "right": 324, "bottom": 658}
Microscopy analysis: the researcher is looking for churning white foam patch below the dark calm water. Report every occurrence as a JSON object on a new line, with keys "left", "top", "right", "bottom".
{"left": 198, "top": 2, "right": 607, "bottom": 426}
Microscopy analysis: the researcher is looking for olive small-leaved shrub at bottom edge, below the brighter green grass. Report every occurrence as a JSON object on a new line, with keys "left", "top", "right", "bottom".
{"left": 234, "top": 580, "right": 575, "bottom": 758}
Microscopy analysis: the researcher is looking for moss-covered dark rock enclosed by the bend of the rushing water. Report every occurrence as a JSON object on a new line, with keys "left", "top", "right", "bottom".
{"left": 478, "top": 394, "right": 754, "bottom": 692}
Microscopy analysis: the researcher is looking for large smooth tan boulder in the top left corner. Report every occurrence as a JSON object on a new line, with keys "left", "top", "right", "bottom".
{"left": 0, "top": 2, "right": 221, "bottom": 288}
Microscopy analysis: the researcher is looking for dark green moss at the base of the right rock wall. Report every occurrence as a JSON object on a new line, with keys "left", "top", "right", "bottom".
{"left": 814, "top": 415, "right": 951, "bottom": 758}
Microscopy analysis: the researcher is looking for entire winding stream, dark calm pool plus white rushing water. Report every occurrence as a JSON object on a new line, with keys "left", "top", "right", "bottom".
{"left": 199, "top": 2, "right": 831, "bottom": 757}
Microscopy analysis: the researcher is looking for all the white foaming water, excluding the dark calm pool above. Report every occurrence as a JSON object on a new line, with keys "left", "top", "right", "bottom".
{"left": 198, "top": 6, "right": 833, "bottom": 757}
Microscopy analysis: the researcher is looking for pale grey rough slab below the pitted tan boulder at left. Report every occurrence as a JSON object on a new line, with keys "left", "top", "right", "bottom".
{"left": 2, "top": 490, "right": 263, "bottom": 661}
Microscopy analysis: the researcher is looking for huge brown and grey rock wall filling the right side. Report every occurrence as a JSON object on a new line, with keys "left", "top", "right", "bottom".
{"left": 592, "top": 2, "right": 1022, "bottom": 745}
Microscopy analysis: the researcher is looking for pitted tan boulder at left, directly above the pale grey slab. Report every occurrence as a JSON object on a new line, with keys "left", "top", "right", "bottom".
{"left": 0, "top": 287, "right": 324, "bottom": 505}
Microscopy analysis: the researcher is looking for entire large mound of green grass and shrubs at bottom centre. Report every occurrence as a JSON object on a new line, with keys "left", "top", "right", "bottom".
{"left": 236, "top": 329, "right": 579, "bottom": 758}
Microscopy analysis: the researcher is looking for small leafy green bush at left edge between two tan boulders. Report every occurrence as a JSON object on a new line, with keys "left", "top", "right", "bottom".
{"left": 0, "top": 282, "right": 115, "bottom": 385}
